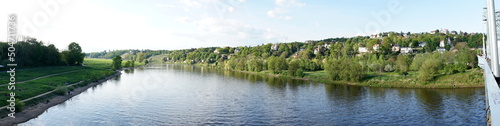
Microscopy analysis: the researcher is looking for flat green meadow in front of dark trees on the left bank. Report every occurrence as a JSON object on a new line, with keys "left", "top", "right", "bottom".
{"left": 0, "top": 59, "right": 114, "bottom": 106}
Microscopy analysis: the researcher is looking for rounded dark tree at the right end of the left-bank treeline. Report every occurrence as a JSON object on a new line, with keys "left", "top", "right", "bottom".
{"left": 61, "top": 42, "right": 85, "bottom": 66}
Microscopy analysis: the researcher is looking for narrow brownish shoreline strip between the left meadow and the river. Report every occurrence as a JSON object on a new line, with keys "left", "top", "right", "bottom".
{"left": 0, "top": 68, "right": 124, "bottom": 126}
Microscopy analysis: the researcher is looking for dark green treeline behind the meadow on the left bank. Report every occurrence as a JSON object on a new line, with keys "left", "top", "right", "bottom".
{"left": 0, "top": 38, "right": 84, "bottom": 68}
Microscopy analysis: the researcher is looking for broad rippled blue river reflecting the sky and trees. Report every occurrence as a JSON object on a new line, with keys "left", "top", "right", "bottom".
{"left": 22, "top": 65, "right": 486, "bottom": 126}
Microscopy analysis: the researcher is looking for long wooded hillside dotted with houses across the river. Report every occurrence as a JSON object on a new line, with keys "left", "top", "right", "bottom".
{"left": 87, "top": 31, "right": 483, "bottom": 81}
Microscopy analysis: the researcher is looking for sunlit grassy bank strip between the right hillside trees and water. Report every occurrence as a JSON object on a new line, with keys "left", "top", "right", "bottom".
{"left": 167, "top": 63, "right": 484, "bottom": 88}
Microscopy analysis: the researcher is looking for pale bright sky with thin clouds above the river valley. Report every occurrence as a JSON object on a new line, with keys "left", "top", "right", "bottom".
{"left": 0, "top": 0, "right": 490, "bottom": 52}
